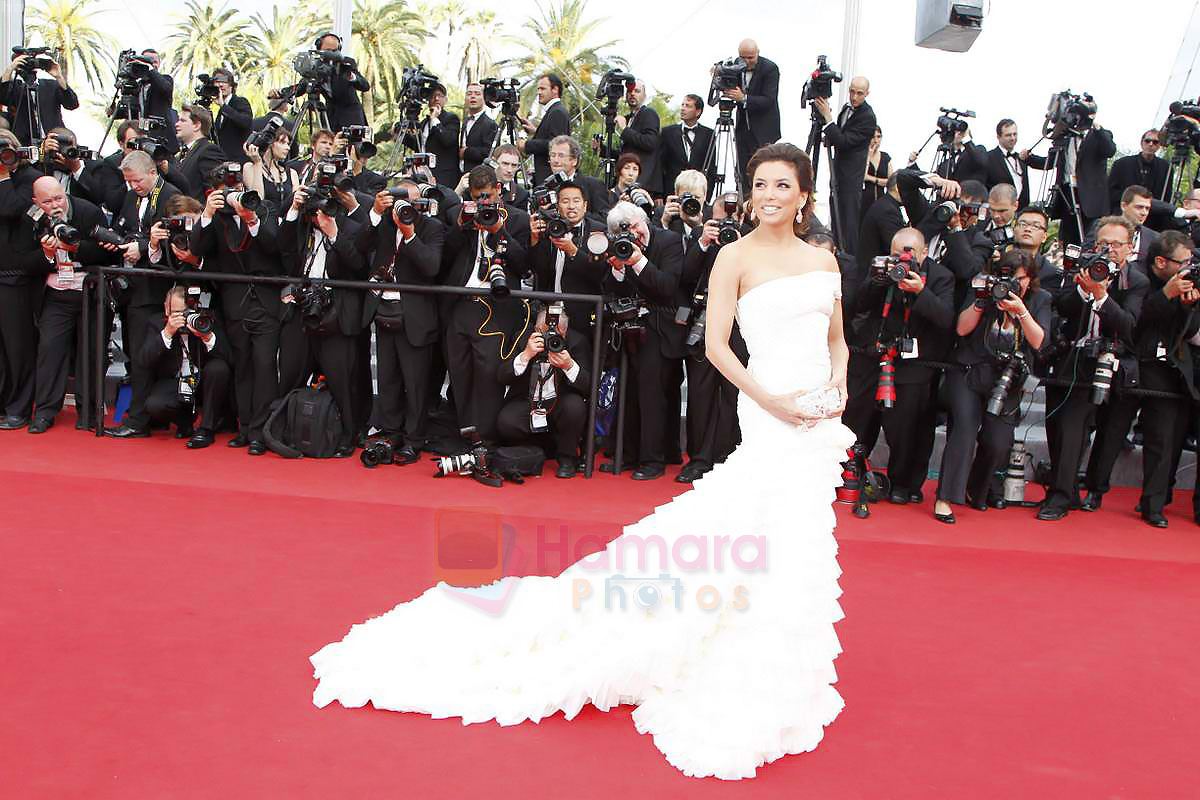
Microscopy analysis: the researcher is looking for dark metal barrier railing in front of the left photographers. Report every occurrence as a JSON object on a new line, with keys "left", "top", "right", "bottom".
{"left": 85, "top": 266, "right": 609, "bottom": 477}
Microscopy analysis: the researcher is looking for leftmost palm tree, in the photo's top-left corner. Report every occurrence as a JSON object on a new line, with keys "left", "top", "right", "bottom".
{"left": 25, "top": 0, "right": 116, "bottom": 89}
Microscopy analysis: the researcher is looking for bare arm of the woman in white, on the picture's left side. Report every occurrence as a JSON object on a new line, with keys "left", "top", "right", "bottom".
{"left": 704, "top": 245, "right": 811, "bottom": 425}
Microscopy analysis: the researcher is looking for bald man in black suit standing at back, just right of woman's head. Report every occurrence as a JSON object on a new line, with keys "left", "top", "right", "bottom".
{"left": 812, "top": 76, "right": 875, "bottom": 253}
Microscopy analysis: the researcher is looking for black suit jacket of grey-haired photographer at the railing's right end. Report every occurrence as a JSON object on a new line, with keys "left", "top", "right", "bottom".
{"left": 601, "top": 228, "right": 695, "bottom": 359}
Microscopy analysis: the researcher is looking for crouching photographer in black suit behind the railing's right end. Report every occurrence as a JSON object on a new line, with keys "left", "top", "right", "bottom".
{"left": 496, "top": 302, "right": 592, "bottom": 477}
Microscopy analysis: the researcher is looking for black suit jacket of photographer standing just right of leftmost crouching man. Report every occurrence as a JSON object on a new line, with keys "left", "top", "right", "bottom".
{"left": 191, "top": 213, "right": 283, "bottom": 323}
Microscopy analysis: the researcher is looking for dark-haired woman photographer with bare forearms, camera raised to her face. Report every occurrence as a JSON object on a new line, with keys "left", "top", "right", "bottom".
{"left": 934, "top": 249, "right": 1051, "bottom": 524}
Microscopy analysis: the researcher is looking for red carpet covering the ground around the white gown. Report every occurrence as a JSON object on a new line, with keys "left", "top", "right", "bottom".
{"left": 0, "top": 417, "right": 1200, "bottom": 799}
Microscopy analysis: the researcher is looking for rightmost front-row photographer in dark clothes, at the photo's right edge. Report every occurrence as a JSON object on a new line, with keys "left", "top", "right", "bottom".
{"left": 1082, "top": 230, "right": 1198, "bottom": 528}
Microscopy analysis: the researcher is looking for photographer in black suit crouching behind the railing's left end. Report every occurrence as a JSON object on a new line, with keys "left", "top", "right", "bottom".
{"left": 136, "top": 287, "right": 229, "bottom": 450}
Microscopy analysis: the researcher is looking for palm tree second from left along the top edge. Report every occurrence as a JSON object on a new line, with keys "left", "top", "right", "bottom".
{"left": 167, "top": 0, "right": 253, "bottom": 80}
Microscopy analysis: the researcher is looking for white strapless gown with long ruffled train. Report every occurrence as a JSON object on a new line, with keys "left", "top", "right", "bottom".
{"left": 311, "top": 272, "right": 853, "bottom": 780}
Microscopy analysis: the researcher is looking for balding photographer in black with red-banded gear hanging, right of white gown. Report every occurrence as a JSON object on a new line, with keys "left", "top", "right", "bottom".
{"left": 842, "top": 227, "right": 954, "bottom": 504}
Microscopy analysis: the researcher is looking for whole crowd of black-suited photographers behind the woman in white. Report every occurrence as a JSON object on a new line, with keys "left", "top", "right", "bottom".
{"left": 0, "top": 34, "right": 1200, "bottom": 527}
